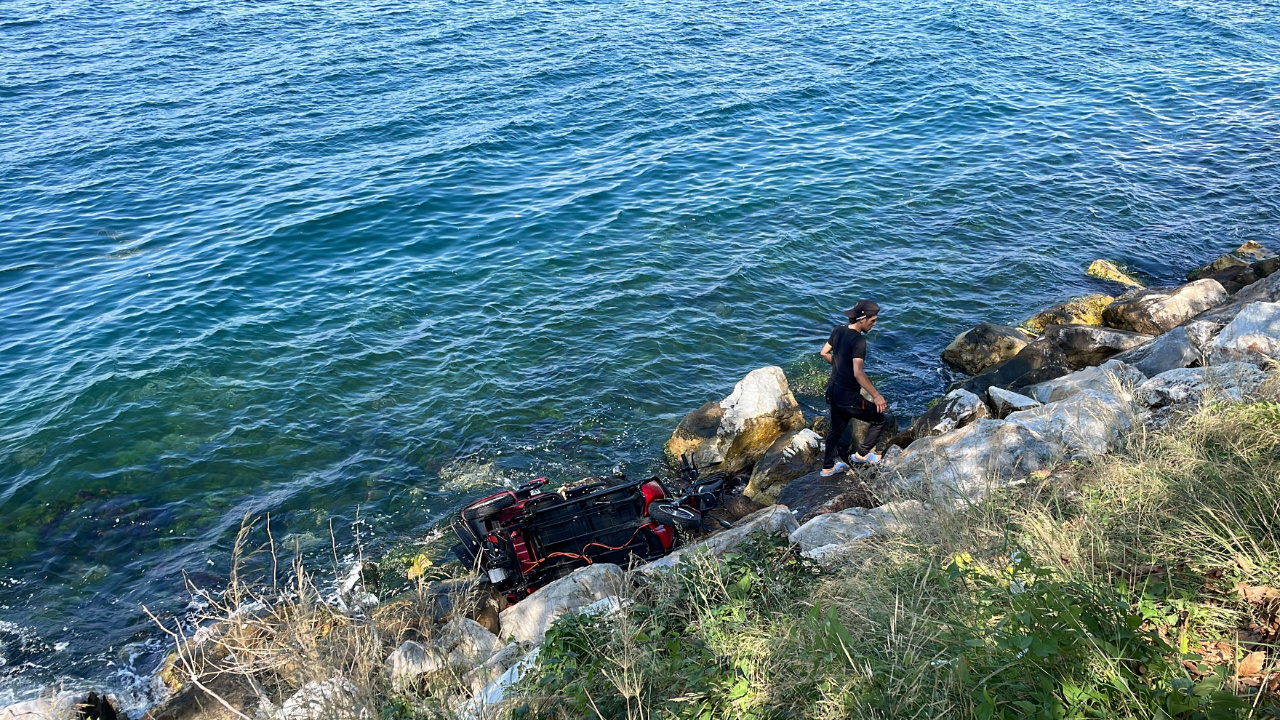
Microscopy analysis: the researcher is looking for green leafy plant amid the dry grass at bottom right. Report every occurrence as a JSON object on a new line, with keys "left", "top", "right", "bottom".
{"left": 943, "top": 552, "right": 1248, "bottom": 720}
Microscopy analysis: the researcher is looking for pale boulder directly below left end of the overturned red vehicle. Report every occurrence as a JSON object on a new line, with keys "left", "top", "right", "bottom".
{"left": 500, "top": 562, "right": 625, "bottom": 643}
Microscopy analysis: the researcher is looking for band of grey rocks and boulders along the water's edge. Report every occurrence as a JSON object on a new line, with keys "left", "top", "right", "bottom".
{"left": 10, "top": 242, "right": 1280, "bottom": 720}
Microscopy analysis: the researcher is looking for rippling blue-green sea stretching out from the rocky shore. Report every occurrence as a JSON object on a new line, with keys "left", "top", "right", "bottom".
{"left": 0, "top": 0, "right": 1280, "bottom": 715}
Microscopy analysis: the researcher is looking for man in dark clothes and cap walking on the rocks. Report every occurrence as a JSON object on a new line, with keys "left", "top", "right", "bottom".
{"left": 822, "top": 300, "right": 888, "bottom": 478}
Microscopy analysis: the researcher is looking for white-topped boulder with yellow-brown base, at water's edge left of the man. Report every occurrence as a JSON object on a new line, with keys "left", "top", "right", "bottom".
{"left": 668, "top": 366, "right": 804, "bottom": 473}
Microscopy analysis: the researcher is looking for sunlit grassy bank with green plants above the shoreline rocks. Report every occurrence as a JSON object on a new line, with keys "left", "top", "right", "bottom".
{"left": 513, "top": 392, "right": 1280, "bottom": 720}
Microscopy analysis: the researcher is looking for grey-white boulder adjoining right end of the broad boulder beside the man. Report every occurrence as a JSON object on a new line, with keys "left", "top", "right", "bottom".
{"left": 1005, "top": 388, "right": 1137, "bottom": 457}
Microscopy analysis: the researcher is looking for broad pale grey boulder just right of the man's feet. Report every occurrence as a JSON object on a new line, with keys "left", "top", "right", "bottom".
{"left": 883, "top": 420, "right": 1055, "bottom": 498}
